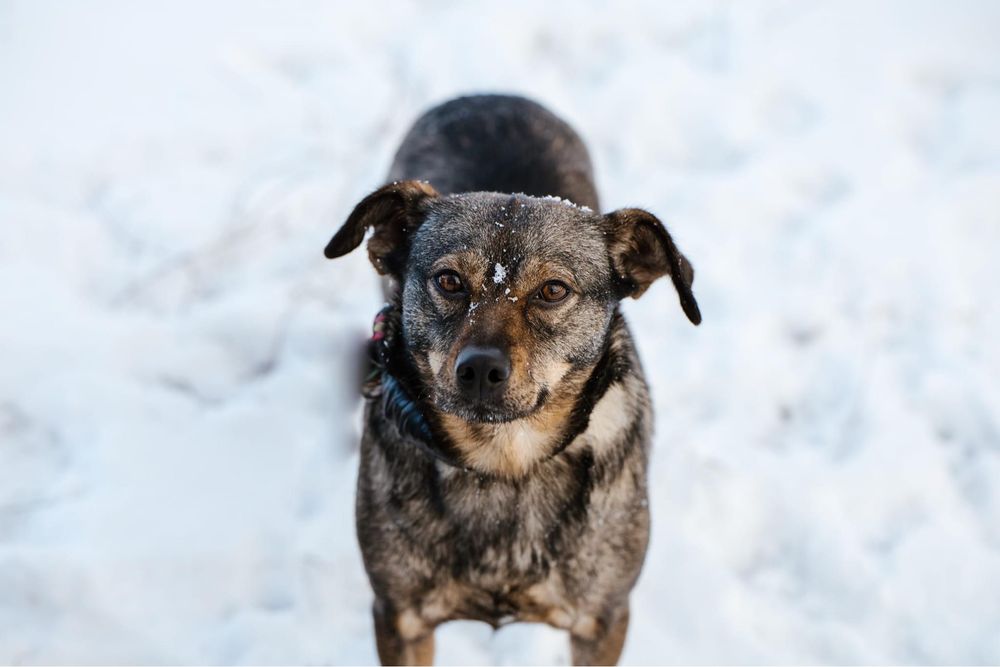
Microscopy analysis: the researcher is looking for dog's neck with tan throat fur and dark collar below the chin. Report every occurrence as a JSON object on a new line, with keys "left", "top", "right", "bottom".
{"left": 365, "top": 304, "right": 628, "bottom": 478}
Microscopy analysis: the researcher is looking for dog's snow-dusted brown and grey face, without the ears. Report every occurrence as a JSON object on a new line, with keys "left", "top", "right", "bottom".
{"left": 402, "top": 193, "right": 618, "bottom": 422}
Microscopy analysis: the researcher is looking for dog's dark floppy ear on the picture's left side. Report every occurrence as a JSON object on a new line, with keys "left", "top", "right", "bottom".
{"left": 323, "top": 181, "right": 438, "bottom": 278}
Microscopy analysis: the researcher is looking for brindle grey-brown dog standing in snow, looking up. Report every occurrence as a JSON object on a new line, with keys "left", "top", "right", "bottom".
{"left": 325, "top": 95, "right": 701, "bottom": 665}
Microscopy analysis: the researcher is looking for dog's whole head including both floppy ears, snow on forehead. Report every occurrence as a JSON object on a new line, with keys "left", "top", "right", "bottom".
{"left": 326, "top": 181, "right": 701, "bottom": 474}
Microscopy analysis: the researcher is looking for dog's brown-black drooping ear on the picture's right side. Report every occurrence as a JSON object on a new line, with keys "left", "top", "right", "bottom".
{"left": 604, "top": 208, "right": 701, "bottom": 324}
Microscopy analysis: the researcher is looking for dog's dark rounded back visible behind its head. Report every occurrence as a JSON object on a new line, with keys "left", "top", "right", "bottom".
{"left": 389, "top": 95, "right": 599, "bottom": 211}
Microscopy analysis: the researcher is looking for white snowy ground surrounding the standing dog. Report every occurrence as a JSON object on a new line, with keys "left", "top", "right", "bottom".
{"left": 0, "top": 0, "right": 1000, "bottom": 664}
